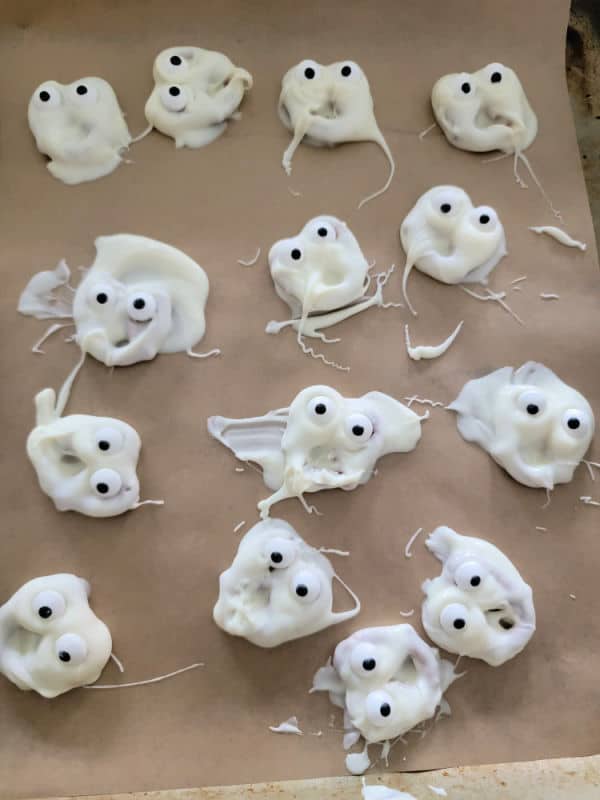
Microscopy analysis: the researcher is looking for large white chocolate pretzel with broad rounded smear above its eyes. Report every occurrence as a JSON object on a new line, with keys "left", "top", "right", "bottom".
{"left": 19, "top": 234, "right": 216, "bottom": 366}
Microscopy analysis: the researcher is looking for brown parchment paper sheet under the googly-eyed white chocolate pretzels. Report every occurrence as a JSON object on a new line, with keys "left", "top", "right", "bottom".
{"left": 0, "top": 0, "right": 600, "bottom": 798}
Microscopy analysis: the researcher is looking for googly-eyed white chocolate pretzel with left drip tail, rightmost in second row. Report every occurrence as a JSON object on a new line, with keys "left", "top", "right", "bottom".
{"left": 400, "top": 186, "right": 506, "bottom": 313}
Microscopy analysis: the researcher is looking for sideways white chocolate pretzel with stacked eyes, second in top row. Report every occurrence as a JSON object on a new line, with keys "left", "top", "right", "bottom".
{"left": 144, "top": 46, "right": 252, "bottom": 147}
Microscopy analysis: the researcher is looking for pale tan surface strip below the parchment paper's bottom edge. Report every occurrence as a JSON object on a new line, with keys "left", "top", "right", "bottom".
{"left": 39, "top": 756, "right": 600, "bottom": 800}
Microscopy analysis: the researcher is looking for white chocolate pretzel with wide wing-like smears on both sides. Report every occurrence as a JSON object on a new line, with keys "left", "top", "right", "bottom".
{"left": 208, "top": 386, "right": 423, "bottom": 518}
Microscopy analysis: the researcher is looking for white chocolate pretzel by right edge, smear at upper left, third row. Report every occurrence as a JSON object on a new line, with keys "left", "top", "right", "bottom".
{"left": 448, "top": 361, "right": 595, "bottom": 489}
